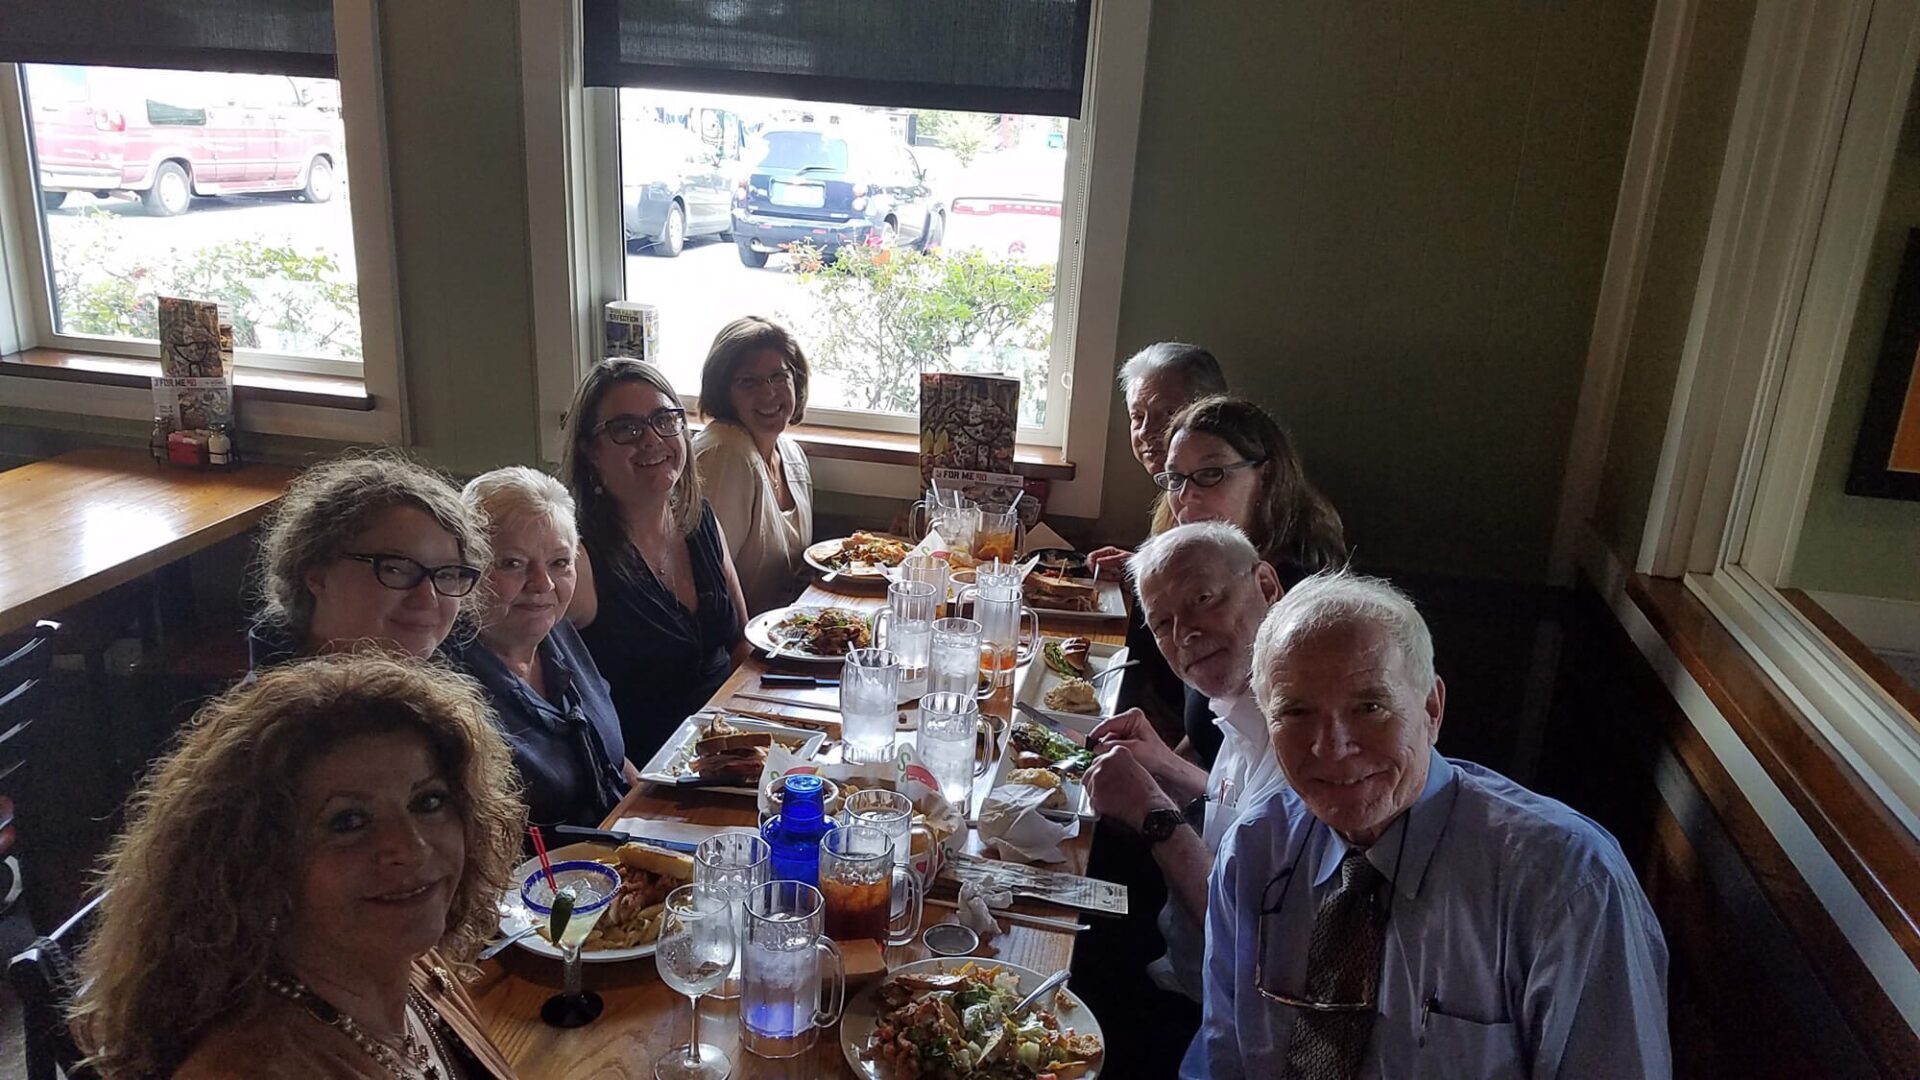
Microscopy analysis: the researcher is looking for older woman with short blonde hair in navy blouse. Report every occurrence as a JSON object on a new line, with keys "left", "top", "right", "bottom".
{"left": 453, "top": 465, "right": 637, "bottom": 826}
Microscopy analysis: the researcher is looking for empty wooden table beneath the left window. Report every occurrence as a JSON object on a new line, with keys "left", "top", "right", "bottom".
{"left": 0, "top": 446, "right": 294, "bottom": 634}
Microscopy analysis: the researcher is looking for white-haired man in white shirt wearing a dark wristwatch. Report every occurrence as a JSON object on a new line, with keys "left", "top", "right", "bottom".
{"left": 1087, "top": 521, "right": 1281, "bottom": 1001}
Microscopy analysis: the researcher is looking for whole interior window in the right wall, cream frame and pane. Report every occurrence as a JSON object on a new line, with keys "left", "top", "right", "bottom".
{"left": 1640, "top": 4, "right": 1920, "bottom": 822}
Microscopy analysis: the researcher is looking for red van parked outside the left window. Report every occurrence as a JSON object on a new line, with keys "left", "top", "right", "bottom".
{"left": 27, "top": 63, "right": 342, "bottom": 217}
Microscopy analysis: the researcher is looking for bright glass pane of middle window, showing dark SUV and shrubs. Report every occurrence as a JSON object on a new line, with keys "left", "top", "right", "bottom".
{"left": 618, "top": 88, "right": 1069, "bottom": 432}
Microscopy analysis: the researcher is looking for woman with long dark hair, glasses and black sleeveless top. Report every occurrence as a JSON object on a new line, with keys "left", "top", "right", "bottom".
{"left": 561, "top": 357, "right": 749, "bottom": 761}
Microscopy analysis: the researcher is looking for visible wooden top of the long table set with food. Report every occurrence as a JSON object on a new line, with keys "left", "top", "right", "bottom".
{"left": 470, "top": 578, "right": 1125, "bottom": 1080}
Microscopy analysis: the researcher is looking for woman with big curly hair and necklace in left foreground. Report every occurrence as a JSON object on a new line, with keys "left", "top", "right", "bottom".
{"left": 73, "top": 653, "right": 526, "bottom": 1080}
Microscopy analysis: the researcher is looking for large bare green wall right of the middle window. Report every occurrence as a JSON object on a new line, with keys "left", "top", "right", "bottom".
{"left": 1100, "top": 0, "right": 1653, "bottom": 580}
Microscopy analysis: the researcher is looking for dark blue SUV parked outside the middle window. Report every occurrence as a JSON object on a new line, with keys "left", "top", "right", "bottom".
{"left": 733, "top": 125, "right": 945, "bottom": 267}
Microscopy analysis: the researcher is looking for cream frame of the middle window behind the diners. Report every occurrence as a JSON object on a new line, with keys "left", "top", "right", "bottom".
{"left": 520, "top": 0, "right": 1152, "bottom": 517}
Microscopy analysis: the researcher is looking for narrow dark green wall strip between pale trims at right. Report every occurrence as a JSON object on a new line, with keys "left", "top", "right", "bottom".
{"left": 1594, "top": 0, "right": 1753, "bottom": 565}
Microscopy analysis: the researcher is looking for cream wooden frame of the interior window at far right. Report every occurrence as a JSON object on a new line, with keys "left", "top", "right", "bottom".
{"left": 1636, "top": 0, "right": 1920, "bottom": 822}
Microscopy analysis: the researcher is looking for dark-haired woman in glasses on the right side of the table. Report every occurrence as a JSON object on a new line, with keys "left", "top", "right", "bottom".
{"left": 1154, "top": 396, "right": 1346, "bottom": 769}
